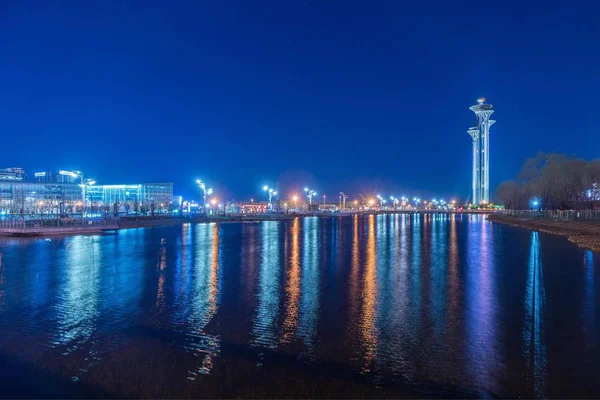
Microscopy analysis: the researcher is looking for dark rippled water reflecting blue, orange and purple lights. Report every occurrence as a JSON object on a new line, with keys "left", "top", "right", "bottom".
{"left": 0, "top": 215, "right": 600, "bottom": 397}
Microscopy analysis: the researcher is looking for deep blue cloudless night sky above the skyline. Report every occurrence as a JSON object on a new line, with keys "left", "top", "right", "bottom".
{"left": 0, "top": 0, "right": 600, "bottom": 199}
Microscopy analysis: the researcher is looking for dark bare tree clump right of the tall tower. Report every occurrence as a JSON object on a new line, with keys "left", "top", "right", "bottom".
{"left": 496, "top": 152, "right": 600, "bottom": 210}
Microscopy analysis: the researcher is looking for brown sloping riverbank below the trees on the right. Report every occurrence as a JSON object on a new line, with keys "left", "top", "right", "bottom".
{"left": 488, "top": 214, "right": 600, "bottom": 252}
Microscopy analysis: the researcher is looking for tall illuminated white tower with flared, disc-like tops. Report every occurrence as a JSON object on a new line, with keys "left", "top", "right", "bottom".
{"left": 467, "top": 97, "right": 496, "bottom": 204}
